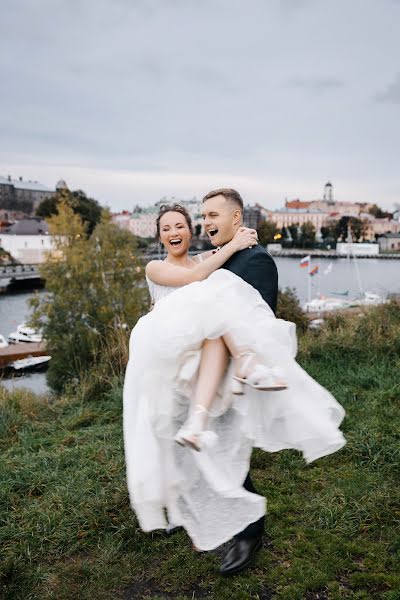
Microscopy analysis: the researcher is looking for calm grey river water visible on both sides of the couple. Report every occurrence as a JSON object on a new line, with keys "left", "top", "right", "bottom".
{"left": 0, "top": 257, "right": 400, "bottom": 393}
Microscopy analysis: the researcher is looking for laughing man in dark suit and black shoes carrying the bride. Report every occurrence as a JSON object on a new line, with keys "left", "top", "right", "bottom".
{"left": 202, "top": 188, "right": 278, "bottom": 575}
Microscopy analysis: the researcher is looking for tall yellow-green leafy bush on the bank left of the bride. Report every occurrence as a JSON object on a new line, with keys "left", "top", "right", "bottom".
{"left": 31, "top": 201, "right": 147, "bottom": 391}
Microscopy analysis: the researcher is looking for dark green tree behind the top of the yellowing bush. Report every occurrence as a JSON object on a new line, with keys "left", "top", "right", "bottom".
{"left": 36, "top": 189, "right": 102, "bottom": 235}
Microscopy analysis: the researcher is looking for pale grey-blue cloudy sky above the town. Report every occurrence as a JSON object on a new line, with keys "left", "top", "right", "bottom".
{"left": 0, "top": 0, "right": 400, "bottom": 210}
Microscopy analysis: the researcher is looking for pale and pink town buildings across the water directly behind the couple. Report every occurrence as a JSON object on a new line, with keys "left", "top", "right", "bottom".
{"left": 112, "top": 182, "right": 400, "bottom": 241}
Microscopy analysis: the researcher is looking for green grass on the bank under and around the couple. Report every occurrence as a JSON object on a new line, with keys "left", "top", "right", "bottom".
{"left": 0, "top": 304, "right": 400, "bottom": 600}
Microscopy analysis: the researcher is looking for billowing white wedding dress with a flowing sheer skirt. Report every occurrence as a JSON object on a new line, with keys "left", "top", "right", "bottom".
{"left": 123, "top": 269, "right": 345, "bottom": 550}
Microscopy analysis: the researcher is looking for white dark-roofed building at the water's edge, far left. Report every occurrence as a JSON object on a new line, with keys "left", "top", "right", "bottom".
{"left": 0, "top": 218, "right": 53, "bottom": 264}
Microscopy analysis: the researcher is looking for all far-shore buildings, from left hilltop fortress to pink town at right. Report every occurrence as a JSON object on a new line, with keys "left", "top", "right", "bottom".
{"left": 0, "top": 177, "right": 400, "bottom": 264}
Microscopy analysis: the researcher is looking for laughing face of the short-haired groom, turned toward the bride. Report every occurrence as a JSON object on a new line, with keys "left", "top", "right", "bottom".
{"left": 202, "top": 195, "right": 242, "bottom": 246}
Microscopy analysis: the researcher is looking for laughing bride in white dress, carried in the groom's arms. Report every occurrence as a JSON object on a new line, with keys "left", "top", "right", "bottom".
{"left": 123, "top": 205, "right": 345, "bottom": 550}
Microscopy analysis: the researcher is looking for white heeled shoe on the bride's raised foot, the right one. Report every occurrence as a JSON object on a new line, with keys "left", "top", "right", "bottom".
{"left": 232, "top": 352, "right": 288, "bottom": 394}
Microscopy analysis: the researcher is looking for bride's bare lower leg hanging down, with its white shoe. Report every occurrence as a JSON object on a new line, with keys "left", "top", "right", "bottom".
{"left": 175, "top": 338, "right": 229, "bottom": 450}
